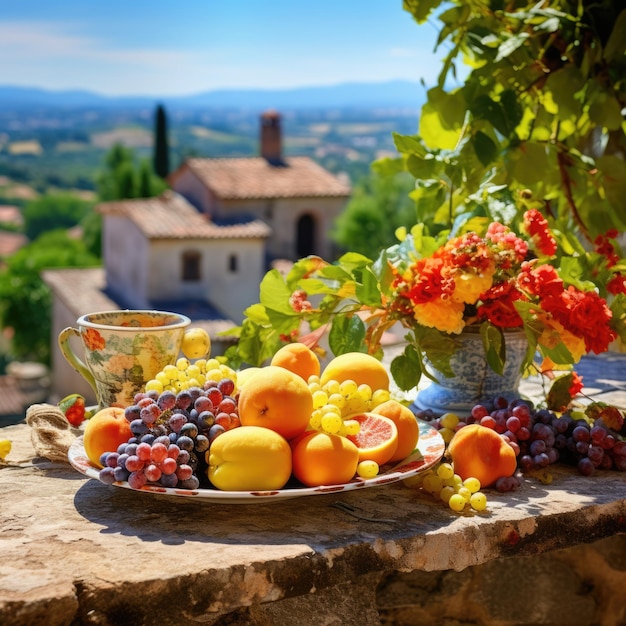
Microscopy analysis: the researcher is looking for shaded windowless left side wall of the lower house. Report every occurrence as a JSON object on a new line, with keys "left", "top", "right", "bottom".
{"left": 102, "top": 215, "right": 152, "bottom": 309}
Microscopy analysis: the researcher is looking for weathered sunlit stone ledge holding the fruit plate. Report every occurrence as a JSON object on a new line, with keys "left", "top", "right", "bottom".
{"left": 0, "top": 424, "right": 626, "bottom": 626}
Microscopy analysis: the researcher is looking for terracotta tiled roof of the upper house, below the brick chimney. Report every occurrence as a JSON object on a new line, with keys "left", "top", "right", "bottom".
{"left": 170, "top": 157, "right": 351, "bottom": 200}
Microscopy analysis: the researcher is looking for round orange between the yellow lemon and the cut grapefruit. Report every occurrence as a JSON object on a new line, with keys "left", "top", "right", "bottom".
{"left": 290, "top": 430, "right": 359, "bottom": 487}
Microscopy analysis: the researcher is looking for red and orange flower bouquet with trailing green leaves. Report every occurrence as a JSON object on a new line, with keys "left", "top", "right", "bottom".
{"left": 228, "top": 208, "right": 626, "bottom": 414}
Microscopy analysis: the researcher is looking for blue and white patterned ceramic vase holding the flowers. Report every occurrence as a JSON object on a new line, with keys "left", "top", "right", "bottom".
{"left": 414, "top": 331, "right": 528, "bottom": 415}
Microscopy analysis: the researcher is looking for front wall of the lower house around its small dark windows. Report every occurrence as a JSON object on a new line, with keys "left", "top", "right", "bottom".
{"left": 146, "top": 239, "right": 264, "bottom": 324}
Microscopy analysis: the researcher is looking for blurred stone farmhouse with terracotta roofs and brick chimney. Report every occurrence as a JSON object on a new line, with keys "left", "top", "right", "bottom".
{"left": 43, "top": 112, "right": 350, "bottom": 401}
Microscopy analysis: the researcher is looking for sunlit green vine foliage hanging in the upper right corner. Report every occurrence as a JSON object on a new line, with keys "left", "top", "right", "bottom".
{"left": 380, "top": 0, "right": 626, "bottom": 239}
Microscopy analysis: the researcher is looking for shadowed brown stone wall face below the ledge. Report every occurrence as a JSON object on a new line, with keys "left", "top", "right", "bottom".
{"left": 210, "top": 535, "right": 626, "bottom": 626}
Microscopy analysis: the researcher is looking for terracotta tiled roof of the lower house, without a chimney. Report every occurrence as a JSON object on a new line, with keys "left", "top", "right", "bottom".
{"left": 96, "top": 191, "right": 271, "bottom": 239}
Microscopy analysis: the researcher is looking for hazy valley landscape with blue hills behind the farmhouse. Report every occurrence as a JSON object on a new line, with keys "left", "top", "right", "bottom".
{"left": 0, "top": 81, "right": 422, "bottom": 199}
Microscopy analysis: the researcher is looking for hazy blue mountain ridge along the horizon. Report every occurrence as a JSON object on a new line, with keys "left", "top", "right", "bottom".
{"left": 0, "top": 80, "right": 424, "bottom": 109}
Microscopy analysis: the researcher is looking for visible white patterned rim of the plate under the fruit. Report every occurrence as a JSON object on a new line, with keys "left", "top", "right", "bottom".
{"left": 68, "top": 420, "right": 445, "bottom": 504}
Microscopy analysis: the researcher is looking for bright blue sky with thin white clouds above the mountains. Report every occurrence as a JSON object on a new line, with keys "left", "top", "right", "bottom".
{"left": 0, "top": 0, "right": 445, "bottom": 95}
